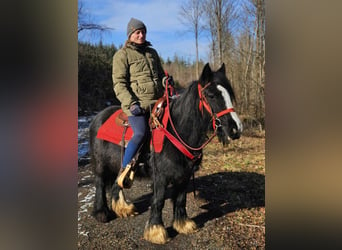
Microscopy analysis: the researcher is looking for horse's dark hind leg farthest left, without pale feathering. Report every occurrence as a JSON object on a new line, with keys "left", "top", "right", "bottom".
{"left": 93, "top": 175, "right": 112, "bottom": 222}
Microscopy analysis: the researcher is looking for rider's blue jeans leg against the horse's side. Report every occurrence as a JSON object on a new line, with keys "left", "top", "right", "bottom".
{"left": 122, "top": 115, "right": 148, "bottom": 168}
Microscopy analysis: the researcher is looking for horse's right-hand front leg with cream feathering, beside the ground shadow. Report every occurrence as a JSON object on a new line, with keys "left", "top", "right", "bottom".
{"left": 172, "top": 184, "right": 197, "bottom": 234}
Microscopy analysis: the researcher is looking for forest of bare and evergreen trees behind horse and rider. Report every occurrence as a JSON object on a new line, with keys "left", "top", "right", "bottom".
{"left": 78, "top": 0, "right": 266, "bottom": 129}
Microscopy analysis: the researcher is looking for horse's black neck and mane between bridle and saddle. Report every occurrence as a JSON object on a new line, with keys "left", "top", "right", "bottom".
{"left": 170, "top": 86, "right": 210, "bottom": 147}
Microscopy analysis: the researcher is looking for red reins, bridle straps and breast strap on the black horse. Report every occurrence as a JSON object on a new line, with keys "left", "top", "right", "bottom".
{"left": 162, "top": 81, "right": 234, "bottom": 160}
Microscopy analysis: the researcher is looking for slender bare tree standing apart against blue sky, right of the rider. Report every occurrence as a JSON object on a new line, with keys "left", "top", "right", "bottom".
{"left": 179, "top": 0, "right": 203, "bottom": 78}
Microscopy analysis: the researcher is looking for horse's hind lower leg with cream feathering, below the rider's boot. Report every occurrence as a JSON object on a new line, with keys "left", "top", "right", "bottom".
{"left": 112, "top": 181, "right": 137, "bottom": 218}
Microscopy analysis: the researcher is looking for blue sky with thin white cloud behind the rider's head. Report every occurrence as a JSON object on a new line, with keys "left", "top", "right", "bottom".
{"left": 78, "top": 0, "right": 209, "bottom": 62}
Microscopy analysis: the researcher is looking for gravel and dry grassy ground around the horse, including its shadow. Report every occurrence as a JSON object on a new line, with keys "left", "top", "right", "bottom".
{"left": 78, "top": 134, "right": 265, "bottom": 249}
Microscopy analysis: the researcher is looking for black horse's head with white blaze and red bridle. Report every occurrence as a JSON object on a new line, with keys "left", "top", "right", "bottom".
{"left": 198, "top": 63, "right": 243, "bottom": 144}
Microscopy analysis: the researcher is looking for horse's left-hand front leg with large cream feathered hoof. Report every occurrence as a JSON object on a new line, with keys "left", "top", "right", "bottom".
{"left": 144, "top": 180, "right": 169, "bottom": 244}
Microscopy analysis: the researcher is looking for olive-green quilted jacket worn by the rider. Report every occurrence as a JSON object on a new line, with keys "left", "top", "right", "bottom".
{"left": 112, "top": 42, "right": 165, "bottom": 115}
